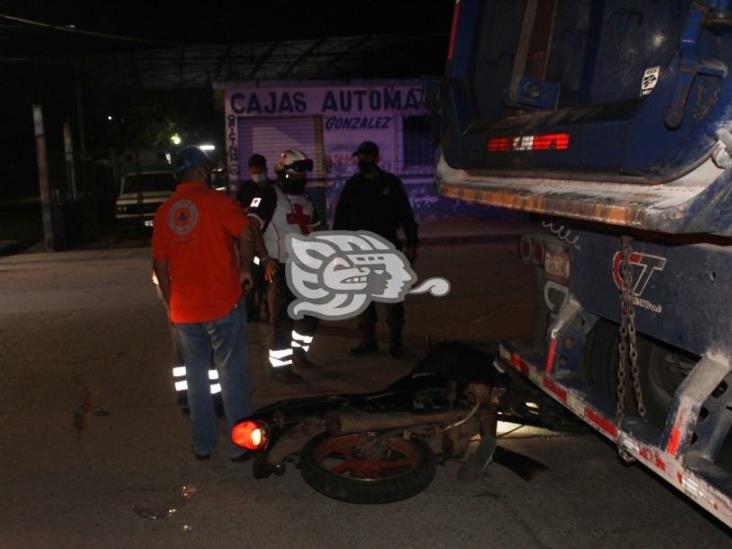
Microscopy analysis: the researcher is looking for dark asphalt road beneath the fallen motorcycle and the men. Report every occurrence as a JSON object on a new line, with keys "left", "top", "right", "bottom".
{"left": 0, "top": 243, "right": 731, "bottom": 549}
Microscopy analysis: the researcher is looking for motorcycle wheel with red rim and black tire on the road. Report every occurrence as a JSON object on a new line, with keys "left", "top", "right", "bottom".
{"left": 300, "top": 433, "right": 435, "bottom": 504}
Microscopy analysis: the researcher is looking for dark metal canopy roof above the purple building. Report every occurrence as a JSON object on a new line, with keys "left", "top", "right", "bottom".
{"left": 82, "top": 35, "right": 446, "bottom": 90}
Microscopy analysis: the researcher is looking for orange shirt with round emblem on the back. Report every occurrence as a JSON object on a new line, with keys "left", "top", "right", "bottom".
{"left": 152, "top": 182, "right": 248, "bottom": 323}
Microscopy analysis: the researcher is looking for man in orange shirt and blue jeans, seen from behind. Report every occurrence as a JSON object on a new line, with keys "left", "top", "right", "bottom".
{"left": 152, "top": 147, "right": 253, "bottom": 461}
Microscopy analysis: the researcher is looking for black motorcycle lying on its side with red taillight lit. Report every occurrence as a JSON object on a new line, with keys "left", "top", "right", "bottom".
{"left": 231, "top": 343, "right": 540, "bottom": 503}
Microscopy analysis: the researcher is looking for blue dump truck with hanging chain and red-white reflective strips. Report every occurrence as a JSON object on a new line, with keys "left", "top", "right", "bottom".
{"left": 437, "top": 0, "right": 732, "bottom": 526}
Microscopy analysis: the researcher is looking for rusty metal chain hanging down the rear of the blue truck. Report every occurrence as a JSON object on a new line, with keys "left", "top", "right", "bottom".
{"left": 616, "top": 236, "right": 646, "bottom": 429}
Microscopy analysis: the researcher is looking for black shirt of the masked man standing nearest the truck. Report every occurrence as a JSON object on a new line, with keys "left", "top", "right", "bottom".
{"left": 333, "top": 170, "right": 417, "bottom": 249}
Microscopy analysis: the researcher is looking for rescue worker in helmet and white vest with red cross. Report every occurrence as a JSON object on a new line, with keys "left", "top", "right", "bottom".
{"left": 247, "top": 149, "right": 320, "bottom": 383}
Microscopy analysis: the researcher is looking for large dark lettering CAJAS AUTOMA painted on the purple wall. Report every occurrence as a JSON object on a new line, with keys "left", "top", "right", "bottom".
{"left": 230, "top": 88, "right": 423, "bottom": 114}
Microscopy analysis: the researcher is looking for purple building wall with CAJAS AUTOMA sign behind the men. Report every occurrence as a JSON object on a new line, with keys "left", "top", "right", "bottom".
{"left": 219, "top": 80, "right": 516, "bottom": 222}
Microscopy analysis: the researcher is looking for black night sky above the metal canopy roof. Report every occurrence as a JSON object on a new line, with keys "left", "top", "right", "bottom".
{"left": 0, "top": 0, "right": 453, "bottom": 56}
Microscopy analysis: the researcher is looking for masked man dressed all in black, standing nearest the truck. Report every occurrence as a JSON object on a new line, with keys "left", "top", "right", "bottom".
{"left": 333, "top": 141, "right": 418, "bottom": 357}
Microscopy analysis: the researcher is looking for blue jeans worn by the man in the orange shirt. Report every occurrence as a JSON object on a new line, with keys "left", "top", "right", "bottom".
{"left": 175, "top": 299, "right": 252, "bottom": 457}
